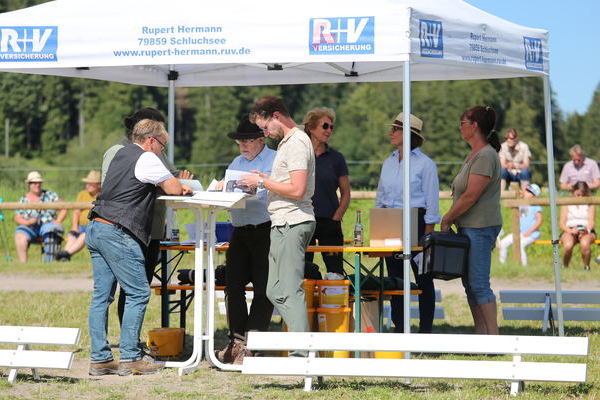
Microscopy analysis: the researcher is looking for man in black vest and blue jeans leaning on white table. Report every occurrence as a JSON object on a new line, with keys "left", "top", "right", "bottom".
{"left": 86, "top": 119, "right": 191, "bottom": 376}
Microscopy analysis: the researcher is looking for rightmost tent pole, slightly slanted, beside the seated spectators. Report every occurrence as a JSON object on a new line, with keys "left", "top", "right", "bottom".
{"left": 543, "top": 75, "right": 565, "bottom": 336}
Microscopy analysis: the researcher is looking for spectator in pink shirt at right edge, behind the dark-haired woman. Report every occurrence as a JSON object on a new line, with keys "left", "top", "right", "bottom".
{"left": 559, "top": 144, "right": 600, "bottom": 191}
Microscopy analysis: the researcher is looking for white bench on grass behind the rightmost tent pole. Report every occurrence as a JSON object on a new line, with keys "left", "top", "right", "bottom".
{"left": 500, "top": 290, "right": 600, "bottom": 332}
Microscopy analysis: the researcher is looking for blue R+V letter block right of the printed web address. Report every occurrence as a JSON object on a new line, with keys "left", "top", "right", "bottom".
{"left": 312, "top": 17, "right": 369, "bottom": 44}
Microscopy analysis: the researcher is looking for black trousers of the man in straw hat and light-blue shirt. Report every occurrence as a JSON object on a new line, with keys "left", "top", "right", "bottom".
{"left": 385, "top": 209, "right": 435, "bottom": 333}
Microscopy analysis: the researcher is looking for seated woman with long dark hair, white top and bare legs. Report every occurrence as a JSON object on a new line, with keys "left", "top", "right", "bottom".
{"left": 560, "top": 181, "right": 596, "bottom": 271}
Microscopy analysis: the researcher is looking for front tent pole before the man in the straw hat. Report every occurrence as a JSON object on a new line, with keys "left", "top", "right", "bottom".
{"left": 402, "top": 61, "right": 412, "bottom": 334}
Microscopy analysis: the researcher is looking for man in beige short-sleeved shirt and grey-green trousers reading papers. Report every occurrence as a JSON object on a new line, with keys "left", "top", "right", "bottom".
{"left": 242, "top": 96, "right": 315, "bottom": 342}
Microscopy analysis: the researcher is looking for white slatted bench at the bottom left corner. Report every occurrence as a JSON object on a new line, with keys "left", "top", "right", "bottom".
{"left": 0, "top": 326, "right": 79, "bottom": 383}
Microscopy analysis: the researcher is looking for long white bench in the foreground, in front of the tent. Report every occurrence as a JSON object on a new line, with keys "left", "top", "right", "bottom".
{"left": 242, "top": 332, "right": 589, "bottom": 395}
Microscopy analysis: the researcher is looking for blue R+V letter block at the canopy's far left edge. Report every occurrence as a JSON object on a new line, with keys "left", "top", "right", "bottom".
{"left": 0, "top": 27, "right": 55, "bottom": 53}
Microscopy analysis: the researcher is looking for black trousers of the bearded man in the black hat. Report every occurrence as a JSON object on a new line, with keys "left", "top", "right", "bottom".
{"left": 225, "top": 222, "right": 273, "bottom": 339}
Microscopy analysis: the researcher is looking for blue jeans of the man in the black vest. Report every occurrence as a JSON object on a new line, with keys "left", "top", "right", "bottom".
{"left": 85, "top": 221, "right": 150, "bottom": 363}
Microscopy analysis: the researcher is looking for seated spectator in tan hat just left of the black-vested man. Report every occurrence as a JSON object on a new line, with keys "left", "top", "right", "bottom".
{"left": 57, "top": 171, "right": 100, "bottom": 261}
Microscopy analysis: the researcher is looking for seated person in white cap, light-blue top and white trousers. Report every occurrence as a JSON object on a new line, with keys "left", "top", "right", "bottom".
{"left": 499, "top": 183, "right": 542, "bottom": 266}
